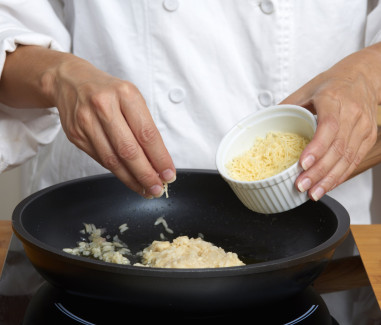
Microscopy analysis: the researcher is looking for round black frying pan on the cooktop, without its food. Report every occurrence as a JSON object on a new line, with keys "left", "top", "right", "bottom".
{"left": 12, "top": 170, "right": 350, "bottom": 311}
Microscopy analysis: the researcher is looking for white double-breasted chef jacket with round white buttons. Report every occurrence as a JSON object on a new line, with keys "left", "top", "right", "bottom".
{"left": 0, "top": 0, "right": 381, "bottom": 322}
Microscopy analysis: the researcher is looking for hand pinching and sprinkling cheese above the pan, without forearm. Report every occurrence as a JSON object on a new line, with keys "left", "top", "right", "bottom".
{"left": 44, "top": 56, "right": 176, "bottom": 198}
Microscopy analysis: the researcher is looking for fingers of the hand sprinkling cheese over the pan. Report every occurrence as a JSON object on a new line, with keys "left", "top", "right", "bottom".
{"left": 89, "top": 84, "right": 175, "bottom": 197}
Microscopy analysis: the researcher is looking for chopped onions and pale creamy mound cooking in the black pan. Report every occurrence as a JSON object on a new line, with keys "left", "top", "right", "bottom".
{"left": 63, "top": 216, "right": 245, "bottom": 268}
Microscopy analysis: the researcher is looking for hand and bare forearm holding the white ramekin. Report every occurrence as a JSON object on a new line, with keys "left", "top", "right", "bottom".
{"left": 281, "top": 43, "right": 381, "bottom": 201}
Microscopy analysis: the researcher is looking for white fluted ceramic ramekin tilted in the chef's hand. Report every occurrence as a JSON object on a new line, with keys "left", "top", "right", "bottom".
{"left": 216, "top": 105, "right": 317, "bottom": 214}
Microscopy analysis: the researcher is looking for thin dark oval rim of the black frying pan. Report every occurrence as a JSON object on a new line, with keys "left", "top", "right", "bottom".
{"left": 12, "top": 169, "right": 350, "bottom": 278}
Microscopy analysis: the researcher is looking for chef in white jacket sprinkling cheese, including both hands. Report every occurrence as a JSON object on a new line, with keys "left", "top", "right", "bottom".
{"left": 0, "top": 0, "right": 381, "bottom": 324}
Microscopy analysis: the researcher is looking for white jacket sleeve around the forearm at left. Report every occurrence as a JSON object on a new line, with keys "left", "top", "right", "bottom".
{"left": 0, "top": 0, "right": 71, "bottom": 173}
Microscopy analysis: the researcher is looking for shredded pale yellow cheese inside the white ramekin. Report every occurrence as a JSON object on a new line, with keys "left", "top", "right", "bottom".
{"left": 226, "top": 132, "right": 310, "bottom": 181}
